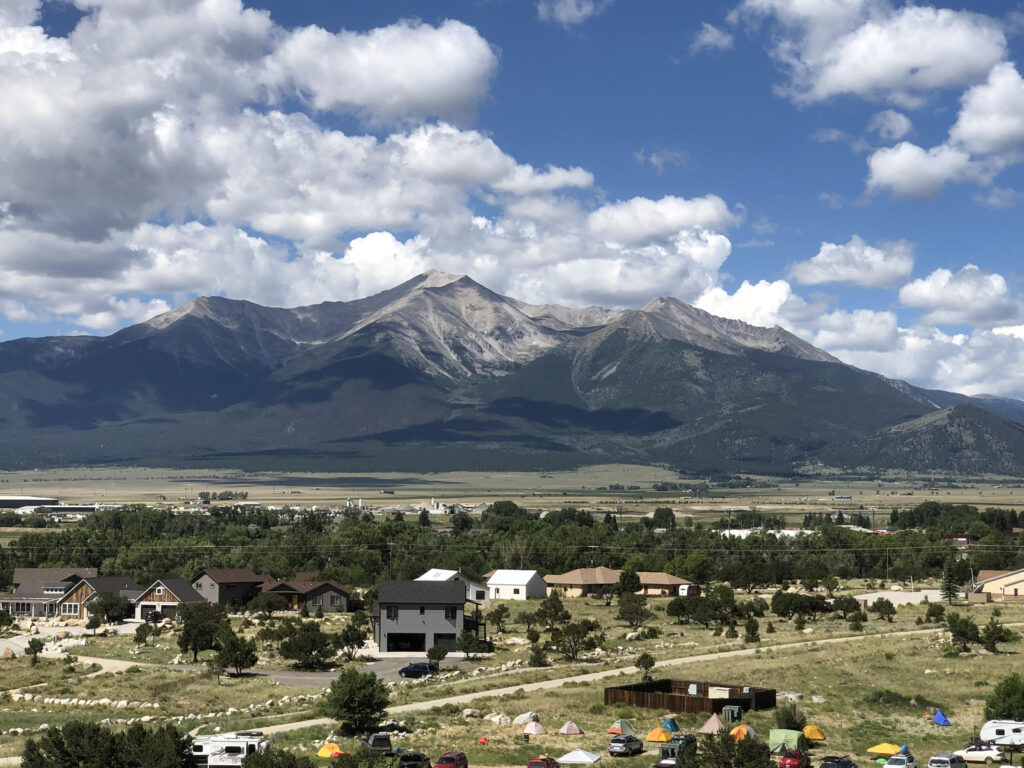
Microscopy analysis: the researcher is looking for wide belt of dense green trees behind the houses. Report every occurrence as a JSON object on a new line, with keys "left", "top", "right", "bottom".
{"left": 6, "top": 502, "right": 1024, "bottom": 592}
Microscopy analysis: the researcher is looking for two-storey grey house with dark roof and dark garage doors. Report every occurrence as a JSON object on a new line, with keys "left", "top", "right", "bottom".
{"left": 372, "top": 581, "right": 485, "bottom": 653}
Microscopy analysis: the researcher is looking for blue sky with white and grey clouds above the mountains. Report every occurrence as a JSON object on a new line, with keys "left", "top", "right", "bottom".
{"left": 0, "top": 0, "right": 1024, "bottom": 398}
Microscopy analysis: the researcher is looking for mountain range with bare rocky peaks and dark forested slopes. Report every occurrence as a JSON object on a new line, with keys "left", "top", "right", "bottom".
{"left": 0, "top": 271, "right": 1024, "bottom": 473}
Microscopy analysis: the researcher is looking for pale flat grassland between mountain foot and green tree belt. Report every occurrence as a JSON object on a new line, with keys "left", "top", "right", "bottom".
{"left": 0, "top": 465, "right": 1024, "bottom": 537}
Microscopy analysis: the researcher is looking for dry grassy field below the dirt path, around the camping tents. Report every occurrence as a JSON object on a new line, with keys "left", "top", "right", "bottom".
{"left": 262, "top": 636, "right": 1022, "bottom": 768}
